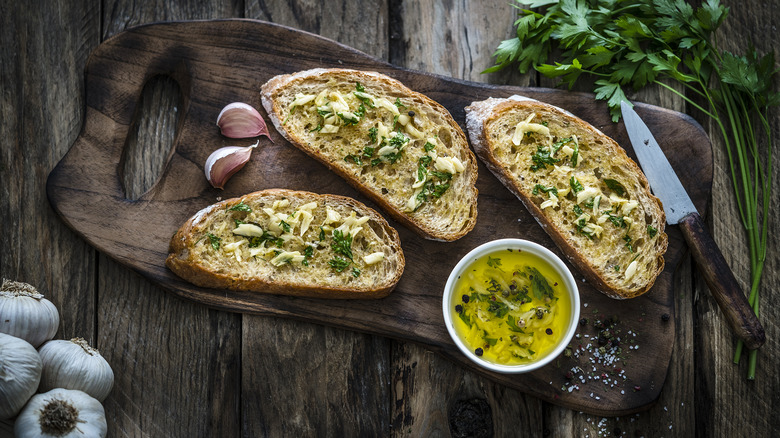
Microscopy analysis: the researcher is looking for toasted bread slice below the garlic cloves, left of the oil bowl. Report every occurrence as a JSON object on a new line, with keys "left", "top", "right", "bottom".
{"left": 166, "top": 189, "right": 404, "bottom": 298}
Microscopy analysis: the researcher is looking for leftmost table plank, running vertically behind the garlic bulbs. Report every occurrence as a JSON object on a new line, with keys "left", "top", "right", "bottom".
{"left": 0, "top": 1, "right": 103, "bottom": 437}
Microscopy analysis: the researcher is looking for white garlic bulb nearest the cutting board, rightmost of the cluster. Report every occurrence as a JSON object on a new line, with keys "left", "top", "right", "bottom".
{"left": 38, "top": 338, "right": 114, "bottom": 402}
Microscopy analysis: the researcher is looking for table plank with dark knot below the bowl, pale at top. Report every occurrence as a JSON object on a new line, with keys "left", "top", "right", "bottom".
{"left": 391, "top": 1, "right": 543, "bottom": 436}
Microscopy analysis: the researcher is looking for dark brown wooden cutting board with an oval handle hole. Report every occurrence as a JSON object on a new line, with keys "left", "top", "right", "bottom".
{"left": 47, "top": 20, "right": 712, "bottom": 415}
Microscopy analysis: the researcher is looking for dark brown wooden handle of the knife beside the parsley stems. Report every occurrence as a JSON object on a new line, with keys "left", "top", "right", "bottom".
{"left": 680, "top": 212, "right": 766, "bottom": 350}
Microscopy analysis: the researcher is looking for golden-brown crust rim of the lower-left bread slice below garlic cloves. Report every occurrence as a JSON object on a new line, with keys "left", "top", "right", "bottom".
{"left": 165, "top": 189, "right": 405, "bottom": 299}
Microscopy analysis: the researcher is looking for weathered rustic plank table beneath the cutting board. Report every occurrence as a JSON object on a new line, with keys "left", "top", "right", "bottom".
{"left": 0, "top": 0, "right": 780, "bottom": 437}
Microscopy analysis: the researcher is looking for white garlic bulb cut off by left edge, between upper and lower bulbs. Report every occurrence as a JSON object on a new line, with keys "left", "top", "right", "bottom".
{"left": 0, "top": 333, "right": 41, "bottom": 420}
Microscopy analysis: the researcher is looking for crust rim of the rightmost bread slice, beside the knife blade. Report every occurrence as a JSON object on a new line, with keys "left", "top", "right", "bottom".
{"left": 466, "top": 96, "right": 668, "bottom": 299}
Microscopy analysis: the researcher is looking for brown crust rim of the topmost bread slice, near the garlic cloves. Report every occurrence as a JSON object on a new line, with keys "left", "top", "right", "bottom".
{"left": 261, "top": 68, "right": 478, "bottom": 241}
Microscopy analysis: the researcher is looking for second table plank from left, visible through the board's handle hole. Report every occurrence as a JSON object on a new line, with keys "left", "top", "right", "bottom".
{"left": 97, "top": 1, "right": 242, "bottom": 437}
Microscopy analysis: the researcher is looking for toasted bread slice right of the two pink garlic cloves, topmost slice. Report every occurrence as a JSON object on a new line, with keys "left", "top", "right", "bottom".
{"left": 262, "top": 69, "right": 477, "bottom": 241}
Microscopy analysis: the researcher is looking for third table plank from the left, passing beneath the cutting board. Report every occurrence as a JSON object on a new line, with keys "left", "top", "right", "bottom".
{"left": 242, "top": 0, "right": 391, "bottom": 437}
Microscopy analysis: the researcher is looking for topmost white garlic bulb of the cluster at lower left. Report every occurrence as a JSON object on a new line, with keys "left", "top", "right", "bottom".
{"left": 0, "top": 279, "right": 60, "bottom": 348}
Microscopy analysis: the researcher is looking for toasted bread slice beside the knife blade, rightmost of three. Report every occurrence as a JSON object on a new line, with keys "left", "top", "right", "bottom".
{"left": 466, "top": 96, "right": 668, "bottom": 299}
